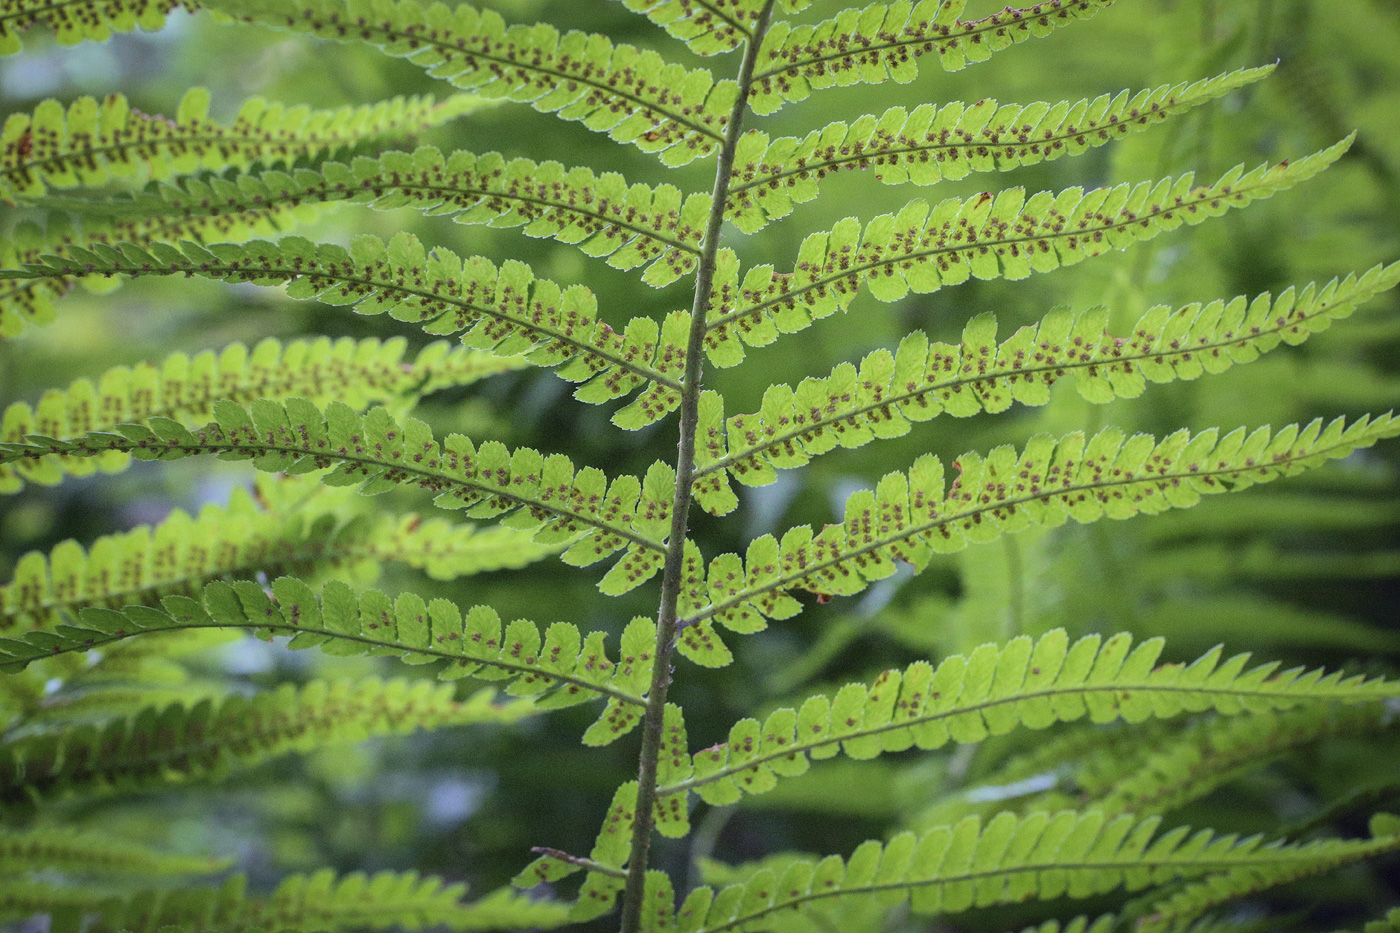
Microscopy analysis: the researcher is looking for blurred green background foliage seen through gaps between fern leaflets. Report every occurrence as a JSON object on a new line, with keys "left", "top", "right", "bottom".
{"left": 0, "top": 0, "right": 1400, "bottom": 929}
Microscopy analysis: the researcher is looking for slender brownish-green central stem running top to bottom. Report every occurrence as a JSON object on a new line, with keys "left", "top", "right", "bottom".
{"left": 622, "top": 0, "right": 774, "bottom": 933}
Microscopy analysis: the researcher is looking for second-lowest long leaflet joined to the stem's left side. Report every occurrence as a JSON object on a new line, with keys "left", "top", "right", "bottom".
{"left": 0, "top": 398, "right": 675, "bottom": 563}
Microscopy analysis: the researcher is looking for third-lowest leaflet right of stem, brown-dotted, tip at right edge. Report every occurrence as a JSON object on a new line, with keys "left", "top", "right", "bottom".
{"left": 680, "top": 415, "right": 1400, "bottom": 632}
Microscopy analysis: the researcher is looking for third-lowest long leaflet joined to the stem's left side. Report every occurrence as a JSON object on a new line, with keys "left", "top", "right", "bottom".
{"left": 0, "top": 233, "right": 690, "bottom": 429}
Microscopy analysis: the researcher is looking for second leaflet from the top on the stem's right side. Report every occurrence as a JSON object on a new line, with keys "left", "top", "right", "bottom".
{"left": 725, "top": 66, "right": 1274, "bottom": 233}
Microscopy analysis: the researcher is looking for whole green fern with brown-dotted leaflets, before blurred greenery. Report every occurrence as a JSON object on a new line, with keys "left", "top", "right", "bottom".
{"left": 0, "top": 0, "right": 1400, "bottom": 933}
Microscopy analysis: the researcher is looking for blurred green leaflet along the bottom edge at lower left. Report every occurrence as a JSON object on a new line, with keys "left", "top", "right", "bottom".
{"left": 0, "top": 870, "right": 568, "bottom": 933}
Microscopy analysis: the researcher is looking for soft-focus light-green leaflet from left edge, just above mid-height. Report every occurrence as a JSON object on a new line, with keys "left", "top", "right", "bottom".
{"left": 0, "top": 338, "right": 525, "bottom": 493}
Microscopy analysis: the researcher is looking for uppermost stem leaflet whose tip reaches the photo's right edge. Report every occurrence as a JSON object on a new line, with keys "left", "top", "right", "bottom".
{"left": 696, "top": 263, "right": 1400, "bottom": 514}
